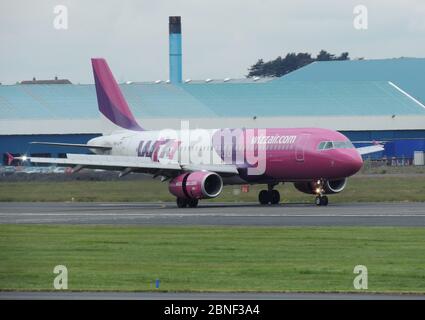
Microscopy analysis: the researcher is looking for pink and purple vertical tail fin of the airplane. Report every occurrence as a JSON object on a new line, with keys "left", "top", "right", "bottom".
{"left": 91, "top": 58, "right": 143, "bottom": 131}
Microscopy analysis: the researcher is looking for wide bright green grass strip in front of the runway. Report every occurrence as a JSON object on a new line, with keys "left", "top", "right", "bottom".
{"left": 0, "top": 225, "right": 425, "bottom": 293}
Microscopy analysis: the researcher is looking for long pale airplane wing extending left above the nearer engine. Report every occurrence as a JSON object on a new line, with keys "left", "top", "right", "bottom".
{"left": 22, "top": 153, "right": 239, "bottom": 177}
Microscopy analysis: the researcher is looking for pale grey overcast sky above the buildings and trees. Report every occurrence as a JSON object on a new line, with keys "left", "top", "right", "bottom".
{"left": 0, "top": 0, "right": 425, "bottom": 84}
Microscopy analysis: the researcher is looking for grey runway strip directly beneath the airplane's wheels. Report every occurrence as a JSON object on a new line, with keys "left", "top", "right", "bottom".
{"left": 0, "top": 202, "right": 425, "bottom": 227}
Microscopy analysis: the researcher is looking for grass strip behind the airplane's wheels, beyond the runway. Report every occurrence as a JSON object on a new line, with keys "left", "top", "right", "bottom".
{"left": 0, "top": 175, "right": 425, "bottom": 203}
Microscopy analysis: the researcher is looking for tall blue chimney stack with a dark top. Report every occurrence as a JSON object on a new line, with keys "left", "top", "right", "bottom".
{"left": 168, "top": 16, "right": 182, "bottom": 84}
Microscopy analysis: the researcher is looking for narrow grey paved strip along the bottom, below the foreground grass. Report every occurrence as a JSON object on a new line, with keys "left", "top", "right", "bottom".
{"left": 0, "top": 291, "right": 425, "bottom": 300}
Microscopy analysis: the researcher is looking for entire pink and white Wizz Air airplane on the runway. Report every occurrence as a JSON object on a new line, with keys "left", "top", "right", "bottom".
{"left": 26, "top": 59, "right": 383, "bottom": 208}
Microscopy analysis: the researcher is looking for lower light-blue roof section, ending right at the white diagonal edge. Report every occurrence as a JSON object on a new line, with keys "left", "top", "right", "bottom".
{"left": 0, "top": 81, "right": 425, "bottom": 119}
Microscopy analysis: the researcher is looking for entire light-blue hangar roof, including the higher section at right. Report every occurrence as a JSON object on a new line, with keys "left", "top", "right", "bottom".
{"left": 0, "top": 59, "right": 425, "bottom": 120}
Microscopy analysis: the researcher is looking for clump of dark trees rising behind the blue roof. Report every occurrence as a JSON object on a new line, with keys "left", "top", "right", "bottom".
{"left": 248, "top": 50, "right": 350, "bottom": 77}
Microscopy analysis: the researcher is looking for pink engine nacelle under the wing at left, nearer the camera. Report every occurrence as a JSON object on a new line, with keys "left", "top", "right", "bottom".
{"left": 168, "top": 171, "right": 223, "bottom": 199}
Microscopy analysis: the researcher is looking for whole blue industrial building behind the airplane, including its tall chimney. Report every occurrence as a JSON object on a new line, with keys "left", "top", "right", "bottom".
{"left": 0, "top": 17, "right": 425, "bottom": 163}
